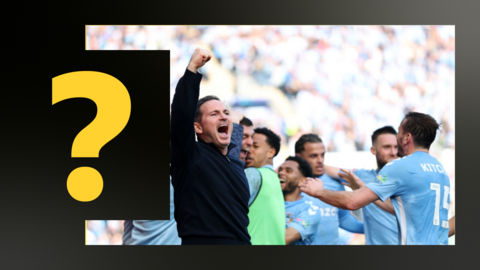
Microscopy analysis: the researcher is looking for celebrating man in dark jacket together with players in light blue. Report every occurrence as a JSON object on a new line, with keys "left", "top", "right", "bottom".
{"left": 123, "top": 48, "right": 455, "bottom": 245}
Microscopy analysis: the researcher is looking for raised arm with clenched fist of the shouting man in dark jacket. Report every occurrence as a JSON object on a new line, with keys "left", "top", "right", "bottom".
{"left": 170, "top": 48, "right": 211, "bottom": 164}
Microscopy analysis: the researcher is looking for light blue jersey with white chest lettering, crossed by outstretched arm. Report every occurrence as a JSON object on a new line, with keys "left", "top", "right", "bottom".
{"left": 311, "top": 174, "right": 364, "bottom": 245}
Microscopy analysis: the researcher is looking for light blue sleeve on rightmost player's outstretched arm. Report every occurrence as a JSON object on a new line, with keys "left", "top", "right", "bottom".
{"left": 366, "top": 162, "right": 408, "bottom": 201}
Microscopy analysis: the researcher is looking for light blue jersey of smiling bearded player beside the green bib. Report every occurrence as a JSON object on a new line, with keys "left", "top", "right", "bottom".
{"left": 285, "top": 193, "right": 320, "bottom": 245}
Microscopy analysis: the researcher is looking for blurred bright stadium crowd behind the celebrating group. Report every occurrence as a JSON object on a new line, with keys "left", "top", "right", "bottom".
{"left": 86, "top": 25, "right": 455, "bottom": 245}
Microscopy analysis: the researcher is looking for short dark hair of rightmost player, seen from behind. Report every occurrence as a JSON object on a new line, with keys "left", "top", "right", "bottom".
{"left": 402, "top": 112, "right": 441, "bottom": 149}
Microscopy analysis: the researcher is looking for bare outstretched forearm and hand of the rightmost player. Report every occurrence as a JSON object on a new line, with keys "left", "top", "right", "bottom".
{"left": 300, "top": 177, "right": 379, "bottom": 210}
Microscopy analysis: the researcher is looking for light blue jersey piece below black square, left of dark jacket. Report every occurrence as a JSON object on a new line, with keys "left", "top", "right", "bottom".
{"left": 123, "top": 177, "right": 182, "bottom": 245}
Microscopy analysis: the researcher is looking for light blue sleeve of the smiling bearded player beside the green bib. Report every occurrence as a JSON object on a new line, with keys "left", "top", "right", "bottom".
{"left": 287, "top": 203, "right": 320, "bottom": 240}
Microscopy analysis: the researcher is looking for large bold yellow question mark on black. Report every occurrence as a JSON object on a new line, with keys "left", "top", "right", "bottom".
{"left": 52, "top": 71, "right": 131, "bottom": 202}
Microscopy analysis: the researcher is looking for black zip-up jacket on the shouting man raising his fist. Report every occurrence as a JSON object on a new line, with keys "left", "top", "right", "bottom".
{"left": 170, "top": 69, "right": 251, "bottom": 245}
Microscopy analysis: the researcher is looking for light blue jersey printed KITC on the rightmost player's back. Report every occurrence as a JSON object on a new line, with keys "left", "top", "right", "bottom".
{"left": 367, "top": 151, "right": 450, "bottom": 245}
